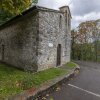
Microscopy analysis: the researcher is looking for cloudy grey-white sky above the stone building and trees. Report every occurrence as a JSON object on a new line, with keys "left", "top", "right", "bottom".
{"left": 38, "top": 0, "right": 100, "bottom": 28}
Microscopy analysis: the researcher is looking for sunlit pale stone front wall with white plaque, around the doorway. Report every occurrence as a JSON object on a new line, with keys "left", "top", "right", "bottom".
{"left": 38, "top": 10, "right": 70, "bottom": 70}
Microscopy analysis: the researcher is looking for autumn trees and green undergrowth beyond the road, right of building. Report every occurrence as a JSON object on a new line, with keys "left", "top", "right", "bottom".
{"left": 72, "top": 20, "right": 100, "bottom": 61}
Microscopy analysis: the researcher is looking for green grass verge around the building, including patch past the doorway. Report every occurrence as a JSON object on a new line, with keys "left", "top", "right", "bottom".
{"left": 0, "top": 63, "right": 74, "bottom": 100}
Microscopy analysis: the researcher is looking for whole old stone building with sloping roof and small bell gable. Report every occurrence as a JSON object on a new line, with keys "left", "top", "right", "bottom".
{"left": 0, "top": 6, "right": 71, "bottom": 71}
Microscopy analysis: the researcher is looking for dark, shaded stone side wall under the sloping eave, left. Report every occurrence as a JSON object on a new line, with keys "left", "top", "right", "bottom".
{"left": 0, "top": 11, "right": 39, "bottom": 70}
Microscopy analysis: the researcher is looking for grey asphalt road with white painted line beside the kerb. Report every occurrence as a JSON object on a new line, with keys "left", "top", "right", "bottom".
{"left": 46, "top": 61, "right": 100, "bottom": 100}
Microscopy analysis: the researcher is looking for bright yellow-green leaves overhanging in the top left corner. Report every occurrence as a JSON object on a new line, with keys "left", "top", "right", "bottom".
{"left": 0, "top": 0, "right": 37, "bottom": 14}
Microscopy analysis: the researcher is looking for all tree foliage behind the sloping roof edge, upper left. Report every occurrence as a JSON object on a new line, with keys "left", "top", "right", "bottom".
{"left": 0, "top": 0, "right": 38, "bottom": 25}
